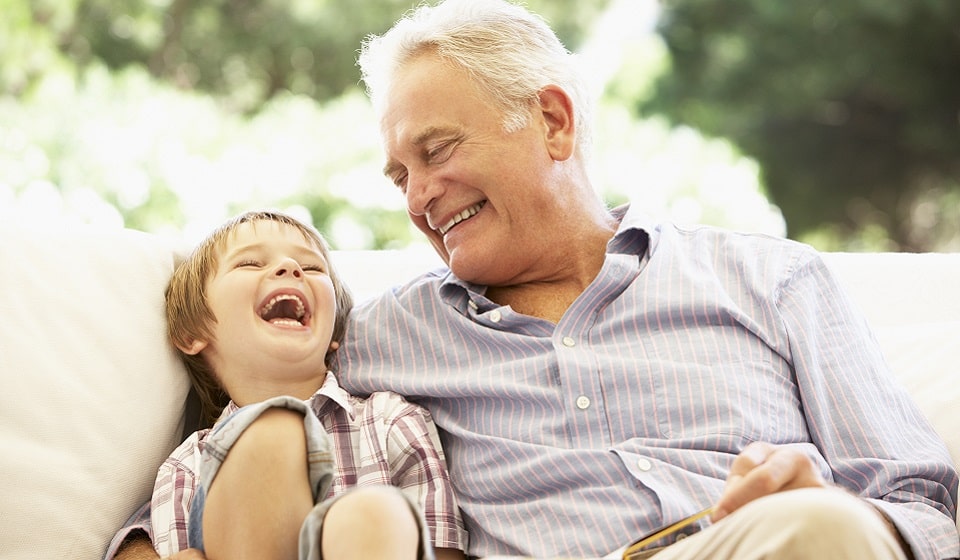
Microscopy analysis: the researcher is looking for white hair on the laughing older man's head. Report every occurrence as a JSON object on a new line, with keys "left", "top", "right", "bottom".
{"left": 358, "top": 0, "right": 592, "bottom": 156}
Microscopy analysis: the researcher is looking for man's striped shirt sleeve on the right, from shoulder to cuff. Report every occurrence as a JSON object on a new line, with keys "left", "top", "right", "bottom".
{"left": 777, "top": 257, "right": 958, "bottom": 560}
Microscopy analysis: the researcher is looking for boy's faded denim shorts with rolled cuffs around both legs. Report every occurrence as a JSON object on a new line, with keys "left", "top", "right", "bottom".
{"left": 187, "top": 396, "right": 433, "bottom": 560}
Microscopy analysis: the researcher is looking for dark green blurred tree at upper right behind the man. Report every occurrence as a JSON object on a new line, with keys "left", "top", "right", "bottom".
{"left": 638, "top": 0, "right": 960, "bottom": 250}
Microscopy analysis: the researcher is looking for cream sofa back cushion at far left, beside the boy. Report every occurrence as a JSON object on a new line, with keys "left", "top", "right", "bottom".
{"left": 0, "top": 224, "right": 189, "bottom": 560}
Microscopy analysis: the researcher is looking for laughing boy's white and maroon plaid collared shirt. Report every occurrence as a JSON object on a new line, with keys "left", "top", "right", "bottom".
{"left": 106, "top": 373, "right": 466, "bottom": 558}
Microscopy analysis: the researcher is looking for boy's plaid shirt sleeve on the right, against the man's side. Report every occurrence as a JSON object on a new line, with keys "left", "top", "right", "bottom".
{"left": 381, "top": 393, "right": 467, "bottom": 551}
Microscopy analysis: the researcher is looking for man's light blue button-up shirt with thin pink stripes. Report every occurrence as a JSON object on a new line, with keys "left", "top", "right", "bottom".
{"left": 338, "top": 209, "right": 960, "bottom": 558}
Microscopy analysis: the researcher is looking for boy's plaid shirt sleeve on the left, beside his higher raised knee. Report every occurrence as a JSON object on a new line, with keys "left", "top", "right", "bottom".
{"left": 149, "top": 430, "right": 209, "bottom": 557}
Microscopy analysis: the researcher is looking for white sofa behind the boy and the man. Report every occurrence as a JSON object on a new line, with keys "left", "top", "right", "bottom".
{"left": 0, "top": 224, "right": 960, "bottom": 560}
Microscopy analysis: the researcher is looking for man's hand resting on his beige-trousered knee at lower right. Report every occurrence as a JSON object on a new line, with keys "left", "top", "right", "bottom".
{"left": 712, "top": 442, "right": 830, "bottom": 521}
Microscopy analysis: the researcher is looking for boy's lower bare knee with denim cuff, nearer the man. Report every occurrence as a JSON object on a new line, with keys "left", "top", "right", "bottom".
{"left": 300, "top": 486, "right": 434, "bottom": 560}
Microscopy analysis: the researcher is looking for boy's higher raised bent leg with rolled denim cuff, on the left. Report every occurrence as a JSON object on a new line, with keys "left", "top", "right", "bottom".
{"left": 188, "top": 397, "right": 333, "bottom": 560}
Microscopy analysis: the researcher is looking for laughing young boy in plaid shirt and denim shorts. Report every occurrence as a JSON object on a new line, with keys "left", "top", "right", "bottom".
{"left": 150, "top": 212, "right": 466, "bottom": 560}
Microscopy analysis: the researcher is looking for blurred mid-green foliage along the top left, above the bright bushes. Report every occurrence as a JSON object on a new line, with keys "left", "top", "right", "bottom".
{"left": 15, "top": 0, "right": 609, "bottom": 112}
